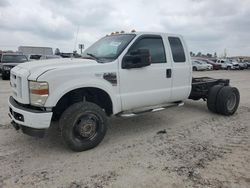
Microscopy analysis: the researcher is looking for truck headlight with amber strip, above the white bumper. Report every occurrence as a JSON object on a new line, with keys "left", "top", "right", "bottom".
{"left": 29, "top": 81, "right": 49, "bottom": 106}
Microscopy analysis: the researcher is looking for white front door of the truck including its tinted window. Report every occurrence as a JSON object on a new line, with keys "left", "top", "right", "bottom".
{"left": 119, "top": 35, "right": 172, "bottom": 111}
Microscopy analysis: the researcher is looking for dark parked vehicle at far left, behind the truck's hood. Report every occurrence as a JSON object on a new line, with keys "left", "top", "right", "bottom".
{"left": 0, "top": 53, "right": 28, "bottom": 80}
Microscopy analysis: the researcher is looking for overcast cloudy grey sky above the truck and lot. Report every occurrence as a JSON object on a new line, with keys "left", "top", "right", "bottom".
{"left": 0, "top": 0, "right": 250, "bottom": 56}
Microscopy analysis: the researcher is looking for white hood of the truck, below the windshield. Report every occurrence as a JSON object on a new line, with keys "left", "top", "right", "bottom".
{"left": 17, "top": 58, "right": 100, "bottom": 80}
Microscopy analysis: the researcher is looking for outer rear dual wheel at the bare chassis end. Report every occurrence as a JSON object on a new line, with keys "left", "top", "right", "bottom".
{"left": 216, "top": 86, "right": 240, "bottom": 116}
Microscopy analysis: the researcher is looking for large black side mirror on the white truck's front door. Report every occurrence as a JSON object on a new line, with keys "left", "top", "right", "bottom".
{"left": 122, "top": 49, "right": 151, "bottom": 69}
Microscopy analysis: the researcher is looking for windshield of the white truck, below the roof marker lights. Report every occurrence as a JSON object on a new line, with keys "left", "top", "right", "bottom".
{"left": 83, "top": 34, "right": 136, "bottom": 62}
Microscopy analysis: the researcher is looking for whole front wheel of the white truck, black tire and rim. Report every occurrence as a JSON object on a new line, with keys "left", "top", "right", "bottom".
{"left": 59, "top": 102, "right": 108, "bottom": 152}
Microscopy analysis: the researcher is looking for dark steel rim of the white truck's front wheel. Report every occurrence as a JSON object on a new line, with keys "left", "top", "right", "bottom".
{"left": 73, "top": 113, "right": 100, "bottom": 141}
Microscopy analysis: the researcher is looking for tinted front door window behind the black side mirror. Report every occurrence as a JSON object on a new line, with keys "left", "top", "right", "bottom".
{"left": 129, "top": 37, "right": 167, "bottom": 63}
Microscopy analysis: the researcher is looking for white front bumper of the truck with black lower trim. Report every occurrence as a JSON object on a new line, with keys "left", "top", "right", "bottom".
{"left": 9, "top": 97, "right": 52, "bottom": 136}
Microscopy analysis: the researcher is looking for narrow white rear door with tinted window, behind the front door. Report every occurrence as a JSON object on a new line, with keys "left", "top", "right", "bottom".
{"left": 168, "top": 36, "right": 192, "bottom": 101}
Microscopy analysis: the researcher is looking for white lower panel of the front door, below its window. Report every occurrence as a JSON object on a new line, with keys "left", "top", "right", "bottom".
{"left": 120, "top": 63, "right": 172, "bottom": 110}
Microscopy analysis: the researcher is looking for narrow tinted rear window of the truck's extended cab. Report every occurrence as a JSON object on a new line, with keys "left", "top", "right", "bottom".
{"left": 168, "top": 37, "right": 186, "bottom": 63}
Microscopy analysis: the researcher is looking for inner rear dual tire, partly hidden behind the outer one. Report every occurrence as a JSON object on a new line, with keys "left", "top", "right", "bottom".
{"left": 207, "top": 85, "right": 223, "bottom": 113}
